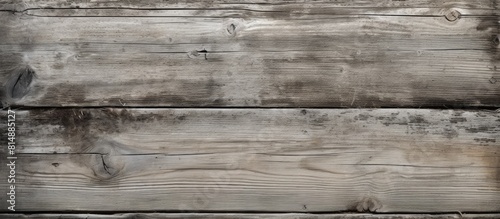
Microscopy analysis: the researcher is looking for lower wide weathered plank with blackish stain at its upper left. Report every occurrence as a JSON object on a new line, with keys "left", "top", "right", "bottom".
{"left": 0, "top": 109, "right": 500, "bottom": 212}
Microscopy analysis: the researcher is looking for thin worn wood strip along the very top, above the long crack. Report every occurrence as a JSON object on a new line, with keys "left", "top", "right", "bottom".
{"left": 0, "top": 0, "right": 496, "bottom": 14}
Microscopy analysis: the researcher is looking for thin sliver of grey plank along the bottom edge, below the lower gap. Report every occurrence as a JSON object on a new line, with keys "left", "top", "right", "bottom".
{"left": 0, "top": 212, "right": 500, "bottom": 219}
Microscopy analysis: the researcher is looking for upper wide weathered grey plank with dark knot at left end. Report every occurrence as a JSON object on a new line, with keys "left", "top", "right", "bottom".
{"left": 0, "top": 0, "right": 500, "bottom": 108}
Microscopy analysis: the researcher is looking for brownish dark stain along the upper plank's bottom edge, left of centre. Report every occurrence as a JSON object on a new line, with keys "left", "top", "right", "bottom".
{"left": 37, "top": 77, "right": 228, "bottom": 106}
